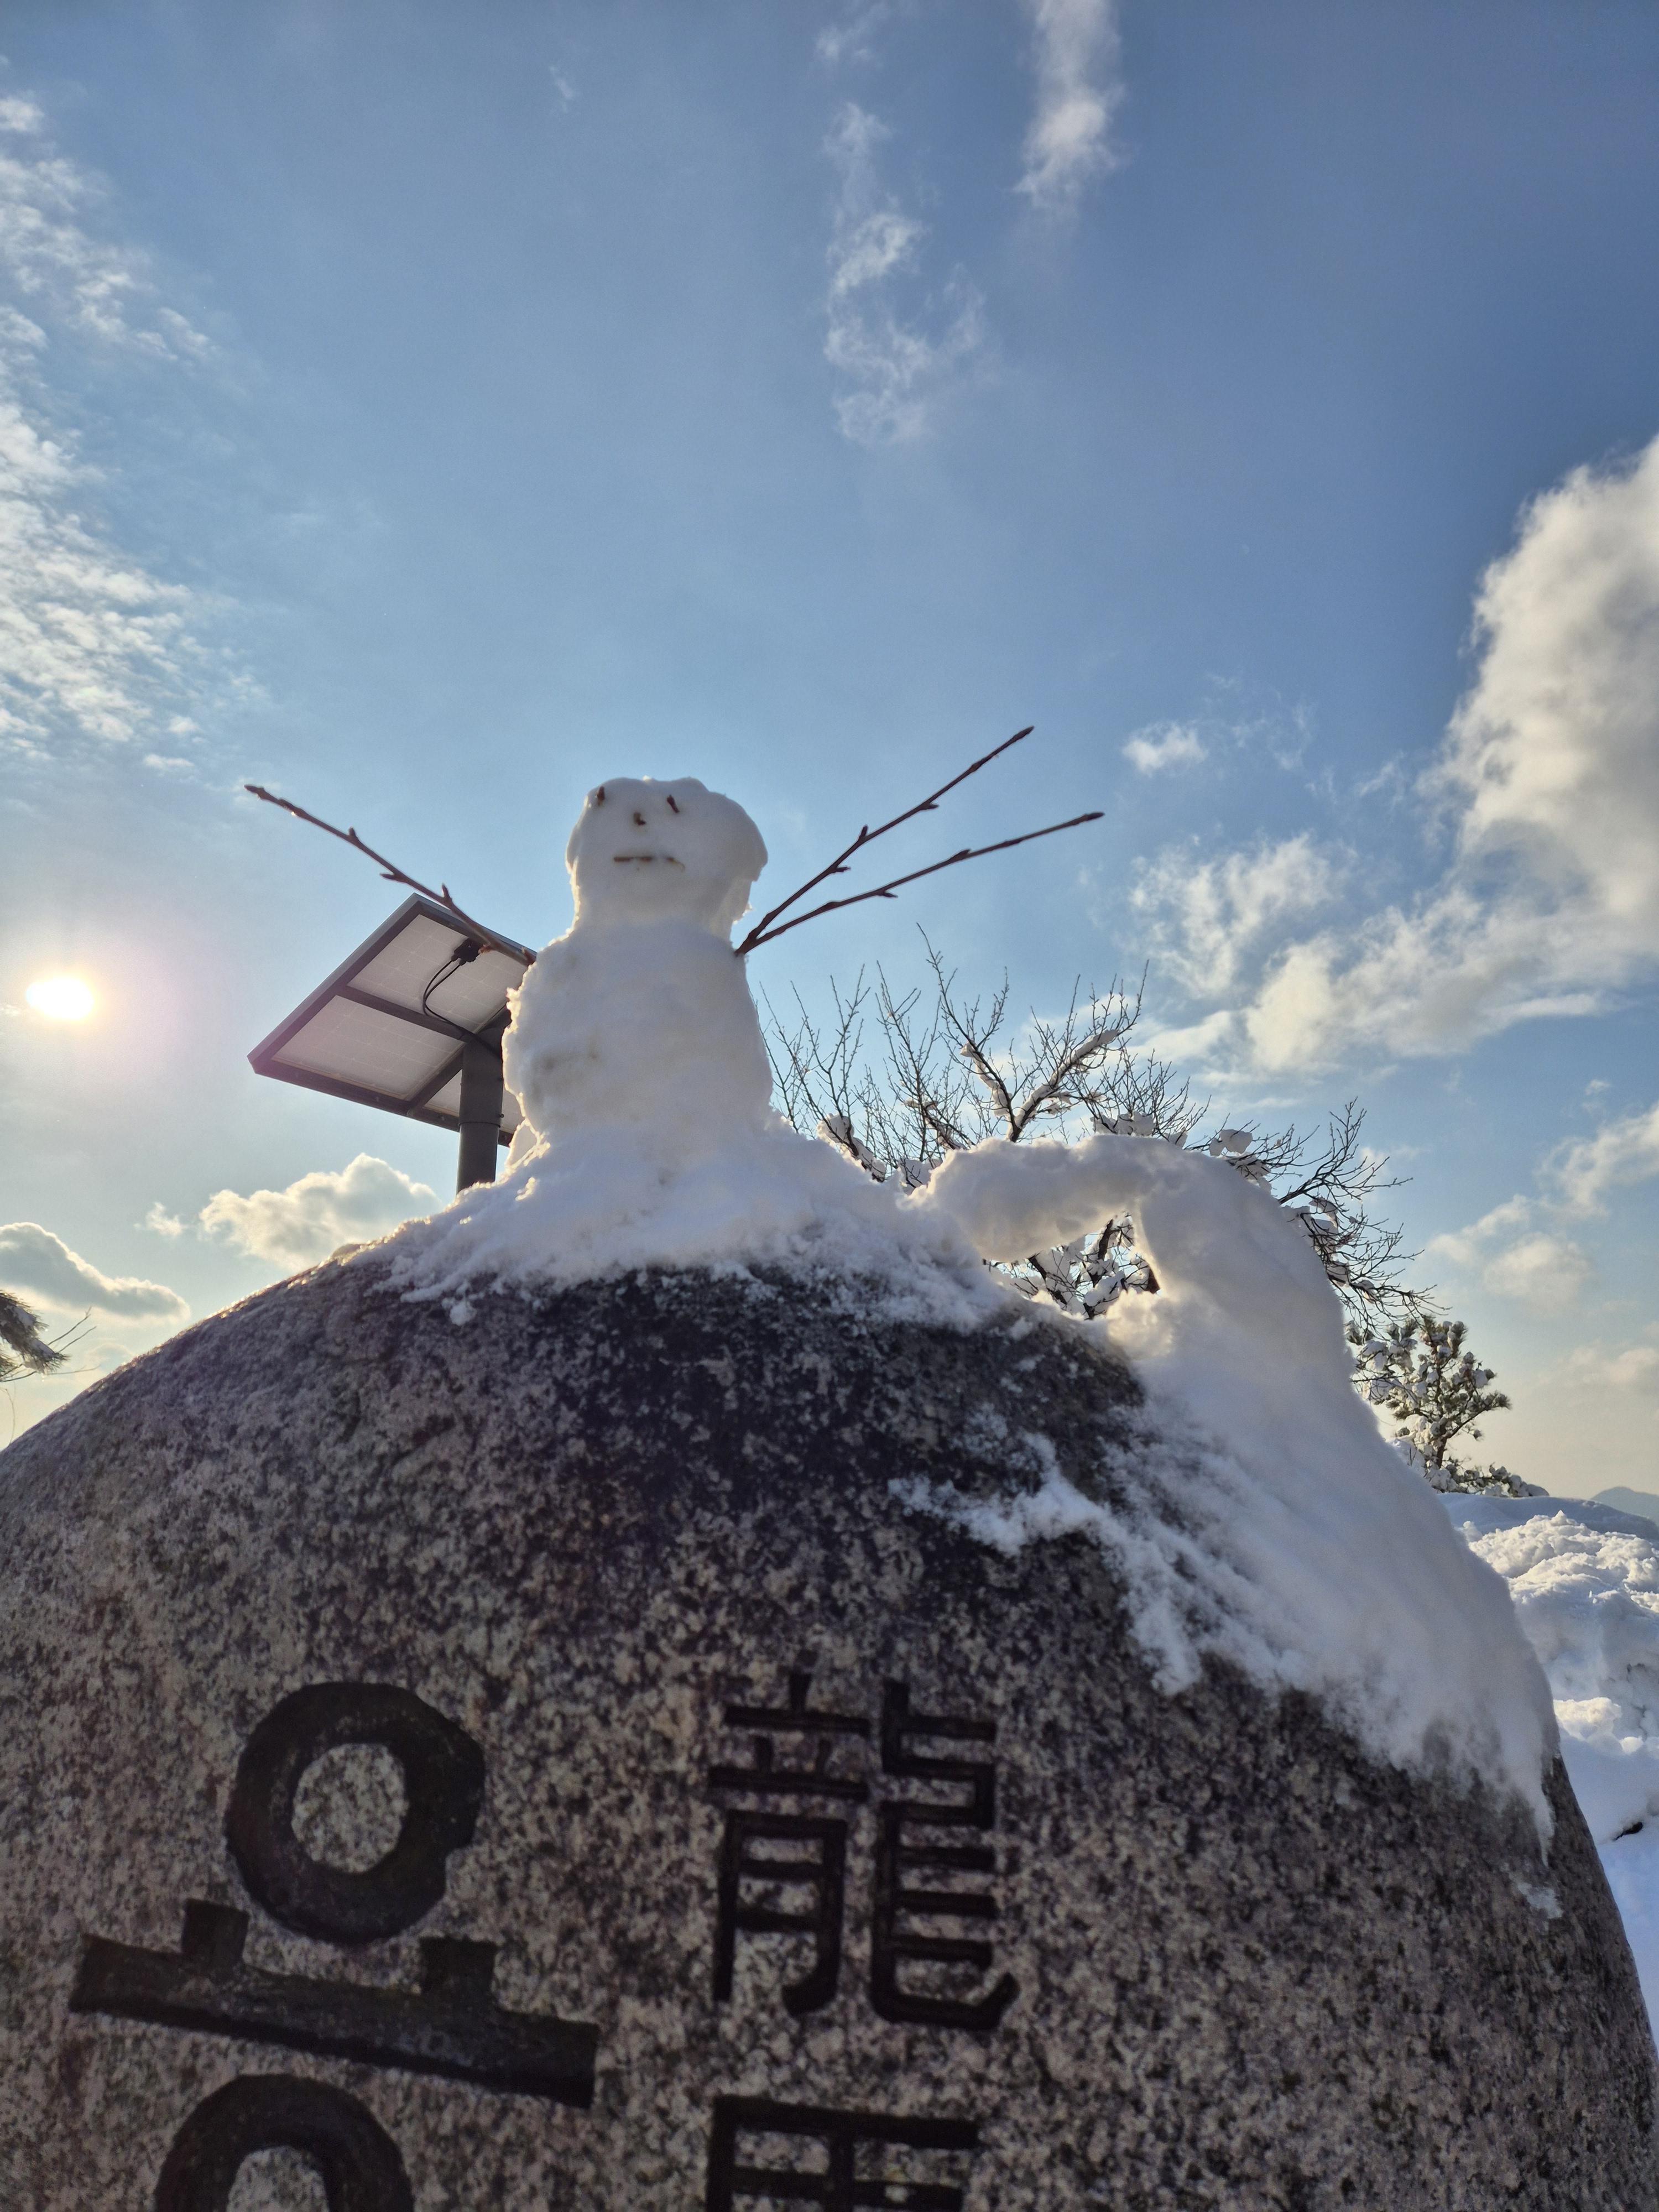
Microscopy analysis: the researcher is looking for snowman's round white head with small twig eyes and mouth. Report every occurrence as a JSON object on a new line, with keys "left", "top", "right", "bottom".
{"left": 564, "top": 776, "right": 765, "bottom": 938}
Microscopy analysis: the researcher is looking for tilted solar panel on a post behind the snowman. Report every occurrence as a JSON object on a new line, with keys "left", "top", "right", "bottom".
{"left": 248, "top": 896, "right": 535, "bottom": 1144}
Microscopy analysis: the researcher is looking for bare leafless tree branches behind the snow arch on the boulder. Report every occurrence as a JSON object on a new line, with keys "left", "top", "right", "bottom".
{"left": 765, "top": 940, "right": 1418, "bottom": 1334}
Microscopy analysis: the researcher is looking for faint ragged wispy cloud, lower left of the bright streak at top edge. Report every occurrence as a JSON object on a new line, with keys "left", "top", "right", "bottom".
{"left": 823, "top": 100, "right": 984, "bottom": 445}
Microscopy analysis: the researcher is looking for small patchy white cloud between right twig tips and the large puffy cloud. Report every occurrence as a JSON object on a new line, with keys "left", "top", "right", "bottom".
{"left": 1130, "top": 834, "right": 1343, "bottom": 1000}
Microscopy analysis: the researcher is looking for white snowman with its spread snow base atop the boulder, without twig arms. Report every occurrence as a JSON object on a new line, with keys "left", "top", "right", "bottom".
{"left": 389, "top": 776, "right": 1000, "bottom": 1321}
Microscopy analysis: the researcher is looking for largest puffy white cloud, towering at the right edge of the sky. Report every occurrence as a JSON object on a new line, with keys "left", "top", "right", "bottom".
{"left": 1148, "top": 440, "right": 1659, "bottom": 1071}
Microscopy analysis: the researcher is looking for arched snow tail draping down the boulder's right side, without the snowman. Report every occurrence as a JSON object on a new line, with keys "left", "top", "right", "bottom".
{"left": 925, "top": 1135, "right": 1555, "bottom": 1834}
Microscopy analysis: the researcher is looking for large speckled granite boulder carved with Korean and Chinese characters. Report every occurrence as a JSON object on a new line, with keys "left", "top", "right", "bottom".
{"left": 0, "top": 1263, "right": 1659, "bottom": 2212}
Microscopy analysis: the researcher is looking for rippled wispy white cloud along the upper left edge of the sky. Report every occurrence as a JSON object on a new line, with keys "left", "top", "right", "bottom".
{"left": 0, "top": 95, "right": 221, "bottom": 763}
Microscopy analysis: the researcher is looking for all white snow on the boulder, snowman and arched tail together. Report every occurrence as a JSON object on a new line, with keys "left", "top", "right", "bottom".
{"left": 380, "top": 779, "right": 1553, "bottom": 1834}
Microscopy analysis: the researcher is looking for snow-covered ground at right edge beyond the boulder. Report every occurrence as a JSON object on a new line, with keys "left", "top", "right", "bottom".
{"left": 1444, "top": 1495, "right": 1659, "bottom": 2024}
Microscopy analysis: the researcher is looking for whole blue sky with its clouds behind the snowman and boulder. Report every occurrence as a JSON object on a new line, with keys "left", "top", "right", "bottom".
{"left": 0, "top": 0, "right": 1659, "bottom": 1493}
